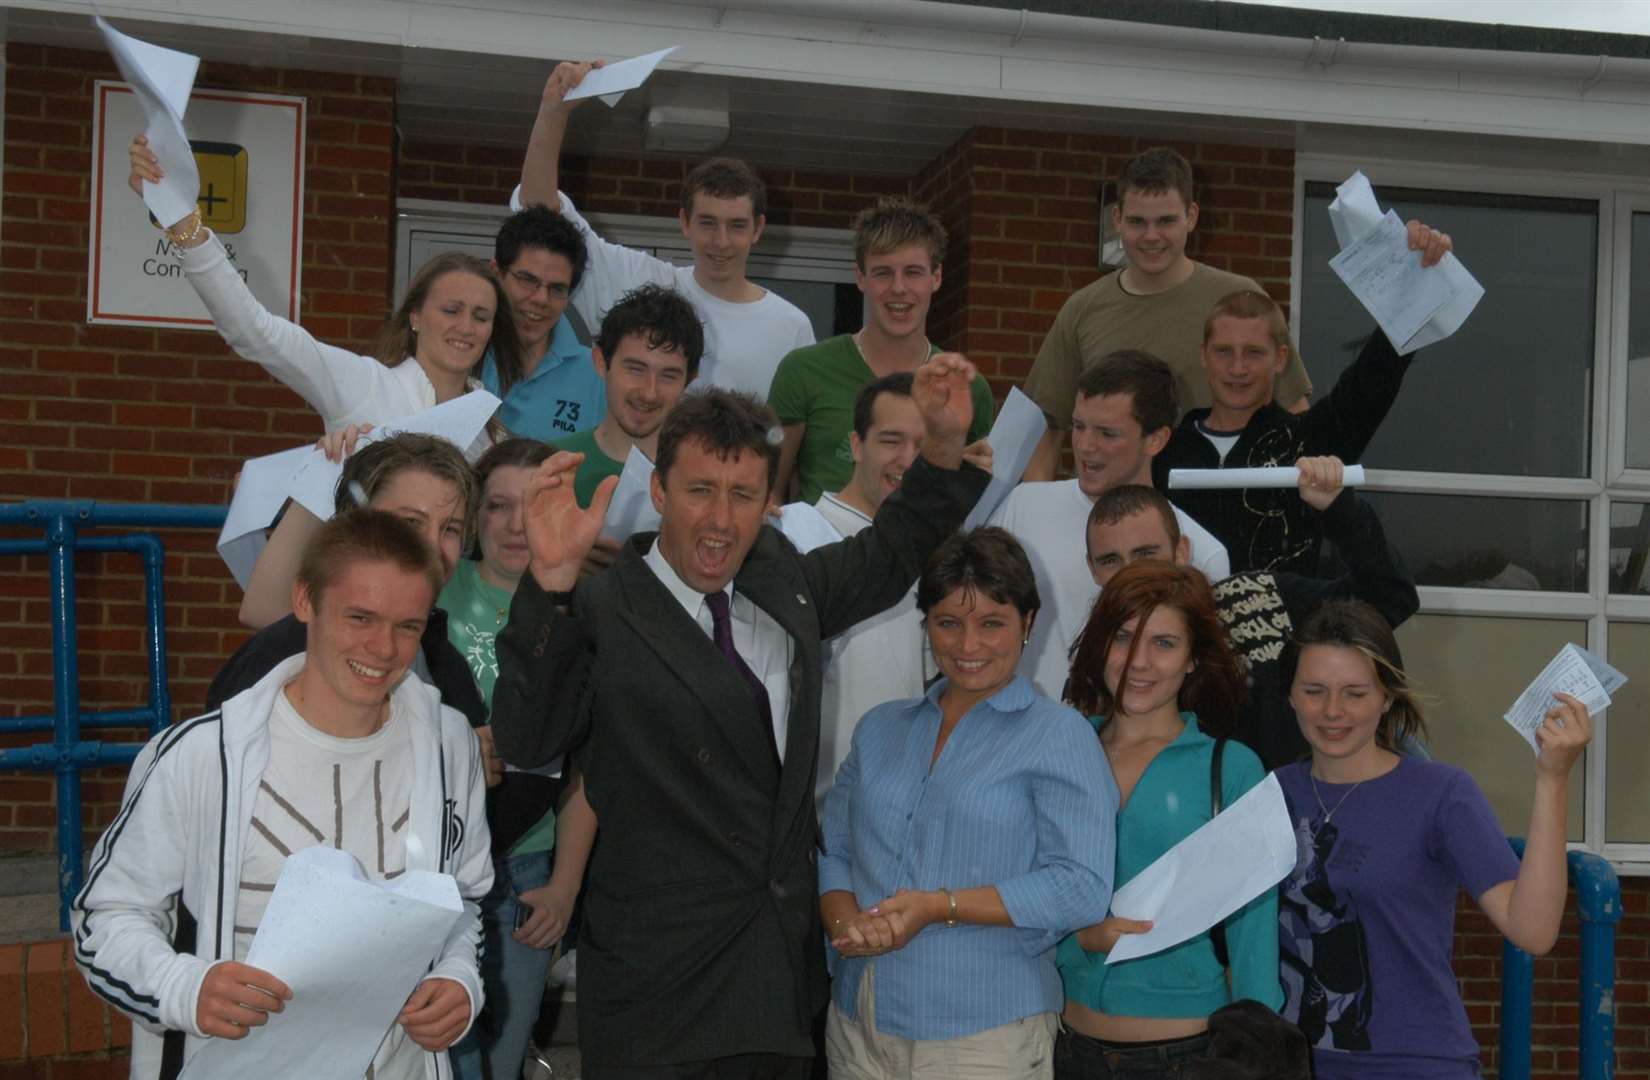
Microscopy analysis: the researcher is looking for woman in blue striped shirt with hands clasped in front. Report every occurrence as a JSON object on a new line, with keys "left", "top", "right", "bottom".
{"left": 820, "top": 528, "right": 1117, "bottom": 1080}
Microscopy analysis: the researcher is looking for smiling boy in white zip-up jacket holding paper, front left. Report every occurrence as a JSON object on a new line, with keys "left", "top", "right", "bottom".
{"left": 73, "top": 509, "right": 493, "bottom": 1080}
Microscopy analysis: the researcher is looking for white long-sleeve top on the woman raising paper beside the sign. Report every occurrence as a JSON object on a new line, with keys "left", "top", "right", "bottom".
{"left": 182, "top": 236, "right": 462, "bottom": 430}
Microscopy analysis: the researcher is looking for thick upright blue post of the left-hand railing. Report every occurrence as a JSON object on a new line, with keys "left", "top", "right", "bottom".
{"left": 46, "top": 511, "right": 83, "bottom": 930}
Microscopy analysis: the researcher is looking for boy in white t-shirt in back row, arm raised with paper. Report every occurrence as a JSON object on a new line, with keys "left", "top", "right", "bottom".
{"left": 510, "top": 63, "right": 813, "bottom": 397}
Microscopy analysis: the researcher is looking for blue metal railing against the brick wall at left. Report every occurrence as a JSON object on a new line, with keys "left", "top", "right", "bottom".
{"left": 0, "top": 501, "right": 226, "bottom": 930}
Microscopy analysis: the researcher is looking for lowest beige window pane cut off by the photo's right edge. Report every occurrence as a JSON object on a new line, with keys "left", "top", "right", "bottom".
{"left": 1604, "top": 623, "right": 1650, "bottom": 844}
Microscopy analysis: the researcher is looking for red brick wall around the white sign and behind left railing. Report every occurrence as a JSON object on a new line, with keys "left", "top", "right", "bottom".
{"left": 0, "top": 43, "right": 394, "bottom": 852}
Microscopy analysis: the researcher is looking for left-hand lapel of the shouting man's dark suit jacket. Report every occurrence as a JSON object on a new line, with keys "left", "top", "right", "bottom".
{"left": 614, "top": 547, "right": 779, "bottom": 785}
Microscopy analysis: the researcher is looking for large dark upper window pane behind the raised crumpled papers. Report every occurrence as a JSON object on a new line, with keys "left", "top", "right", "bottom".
{"left": 1297, "top": 183, "right": 1597, "bottom": 477}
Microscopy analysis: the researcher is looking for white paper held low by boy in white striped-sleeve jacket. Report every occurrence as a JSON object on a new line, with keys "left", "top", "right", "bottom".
{"left": 182, "top": 848, "right": 465, "bottom": 1080}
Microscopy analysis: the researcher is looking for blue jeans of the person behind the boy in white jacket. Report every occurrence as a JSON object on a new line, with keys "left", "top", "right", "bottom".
{"left": 450, "top": 851, "right": 549, "bottom": 1080}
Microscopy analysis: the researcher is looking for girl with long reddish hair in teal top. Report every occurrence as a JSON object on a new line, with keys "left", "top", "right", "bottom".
{"left": 1054, "top": 561, "right": 1284, "bottom": 1080}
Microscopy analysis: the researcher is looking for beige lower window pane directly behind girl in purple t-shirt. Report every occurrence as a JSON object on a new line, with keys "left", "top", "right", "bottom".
{"left": 1398, "top": 615, "right": 1584, "bottom": 841}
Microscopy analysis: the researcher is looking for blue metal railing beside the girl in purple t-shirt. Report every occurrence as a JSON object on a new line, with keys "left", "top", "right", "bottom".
{"left": 1500, "top": 838, "right": 1622, "bottom": 1080}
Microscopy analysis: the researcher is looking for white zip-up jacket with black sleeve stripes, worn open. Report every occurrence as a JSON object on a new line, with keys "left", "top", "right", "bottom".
{"left": 73, "top": 653, "right": 493, "bottom": 1080}
